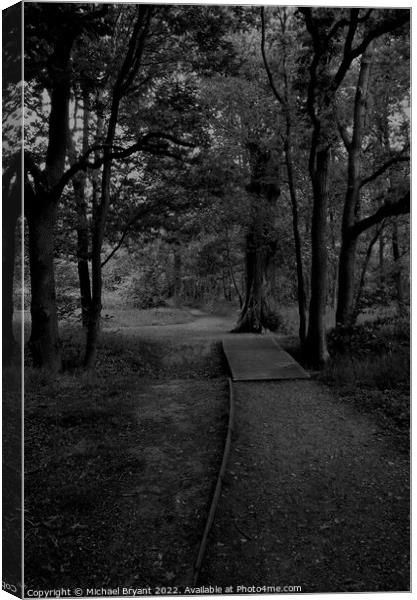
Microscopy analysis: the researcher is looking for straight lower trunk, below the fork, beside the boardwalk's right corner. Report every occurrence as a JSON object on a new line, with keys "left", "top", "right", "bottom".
{"left": 305, "top": 146, "right": 330, "bottom": 368}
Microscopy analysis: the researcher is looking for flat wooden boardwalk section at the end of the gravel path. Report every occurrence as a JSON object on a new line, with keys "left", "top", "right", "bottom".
{"left": 223, "top": 334, "right": 309, "bottom": 381}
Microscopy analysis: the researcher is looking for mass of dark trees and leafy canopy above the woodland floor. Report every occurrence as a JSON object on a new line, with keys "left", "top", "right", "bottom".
{"left": 3, "top": 3, "right": 410, "bottom": 369}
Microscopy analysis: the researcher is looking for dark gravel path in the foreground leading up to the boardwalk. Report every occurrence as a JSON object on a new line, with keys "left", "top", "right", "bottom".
{"left": 199, "top": 381, "right": 409, "bottom": 592}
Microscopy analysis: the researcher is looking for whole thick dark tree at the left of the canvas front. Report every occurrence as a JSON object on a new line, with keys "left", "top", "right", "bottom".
{"left": 25, "top": 4, "right": 106, "bottom": 372}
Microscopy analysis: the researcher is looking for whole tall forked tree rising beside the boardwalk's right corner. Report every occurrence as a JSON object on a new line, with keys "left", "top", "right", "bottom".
{"left": 299, "top": 8, "right": 409, "bottom": 366}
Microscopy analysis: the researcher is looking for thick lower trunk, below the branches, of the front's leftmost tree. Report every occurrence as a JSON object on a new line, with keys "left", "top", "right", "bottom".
{"left": 27, "top": 197, "right": 61, "bottom": 373}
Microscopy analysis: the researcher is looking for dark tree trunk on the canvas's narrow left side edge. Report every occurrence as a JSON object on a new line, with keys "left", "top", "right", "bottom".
{"left": 2, "top": 166, "right": 21, "bottom": 366}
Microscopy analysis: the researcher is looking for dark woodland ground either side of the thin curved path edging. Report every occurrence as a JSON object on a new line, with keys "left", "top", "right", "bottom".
{"left": 25, "top": 309, "right": 409, "bottom": 592}
